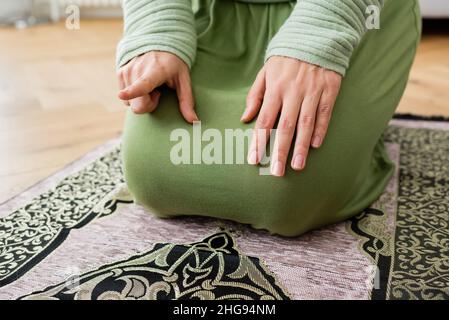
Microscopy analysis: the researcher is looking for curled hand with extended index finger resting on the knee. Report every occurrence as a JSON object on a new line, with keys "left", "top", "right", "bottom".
{"left": 117, "top": 51, "right": 198, "bottom": 123}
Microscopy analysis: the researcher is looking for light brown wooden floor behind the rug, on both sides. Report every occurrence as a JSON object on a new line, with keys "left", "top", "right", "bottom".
{"left": 0, "top": 20, "right": 449, "bottom": 203}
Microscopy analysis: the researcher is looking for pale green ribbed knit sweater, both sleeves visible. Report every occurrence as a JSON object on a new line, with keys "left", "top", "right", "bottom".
{"left": 117, "top": 0, "right": 384, "bottom": 75}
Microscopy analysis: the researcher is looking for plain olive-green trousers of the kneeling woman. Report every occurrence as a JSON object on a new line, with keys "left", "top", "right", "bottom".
{"left": 122, "top": 0, "right": 421, "bottom": 236}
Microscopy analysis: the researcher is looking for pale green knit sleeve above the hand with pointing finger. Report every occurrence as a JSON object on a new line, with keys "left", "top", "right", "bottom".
{"left": 116, "top": 0, "right": 197, "bottom": 68}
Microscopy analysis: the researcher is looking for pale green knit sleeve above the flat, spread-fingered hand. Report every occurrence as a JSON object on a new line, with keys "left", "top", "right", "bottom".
{"left": 265, "top": 0, "right": 384, "bottom": 75}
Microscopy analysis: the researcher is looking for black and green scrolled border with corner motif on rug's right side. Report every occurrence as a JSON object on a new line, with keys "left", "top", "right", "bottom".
{"left": 350, "top": 122, "right": 449, "bottom": 299}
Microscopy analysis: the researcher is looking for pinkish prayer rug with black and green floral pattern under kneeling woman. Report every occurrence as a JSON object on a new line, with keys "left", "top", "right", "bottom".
{"left": 0, "top": 120, "right": 449, "bottom": 299}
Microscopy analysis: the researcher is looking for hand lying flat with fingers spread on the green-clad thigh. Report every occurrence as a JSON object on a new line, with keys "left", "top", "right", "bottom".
{"left": 241, "top": 56, "right": 341, "bottom": 177}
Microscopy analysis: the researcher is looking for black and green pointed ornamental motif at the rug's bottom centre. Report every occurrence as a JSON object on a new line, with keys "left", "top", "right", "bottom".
{"left": 20, "top": 232, "right": 288, "bottom": 300}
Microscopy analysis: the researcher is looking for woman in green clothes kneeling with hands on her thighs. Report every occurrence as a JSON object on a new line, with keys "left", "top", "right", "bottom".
{"left": 117, "top": 0, "right": 420, "bottom": 236}
